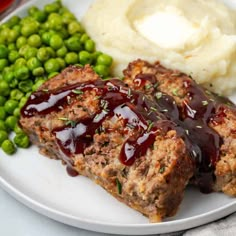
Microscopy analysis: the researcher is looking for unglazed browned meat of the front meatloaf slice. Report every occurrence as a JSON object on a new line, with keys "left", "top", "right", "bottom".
{"left": 20, "top": 66, "right": 193, "bottom": 222}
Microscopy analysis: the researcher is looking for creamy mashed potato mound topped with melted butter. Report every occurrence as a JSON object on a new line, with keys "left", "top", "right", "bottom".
{"left": 82, "top": 0, "right": 236, "bottom": 95}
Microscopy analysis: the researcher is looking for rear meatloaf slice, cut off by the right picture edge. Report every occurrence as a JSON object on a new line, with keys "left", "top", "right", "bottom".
{"left": 124, "top": 60, "right": 236, "bottom": 196}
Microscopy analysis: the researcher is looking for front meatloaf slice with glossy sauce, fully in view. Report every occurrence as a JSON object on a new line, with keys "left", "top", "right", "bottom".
{"left": 20, "top": 66, "right": 194, "bottom": 222}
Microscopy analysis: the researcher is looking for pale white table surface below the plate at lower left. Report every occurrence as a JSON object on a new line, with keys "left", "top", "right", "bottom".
{"left": 0, "top": 188, "right": 107, "bottom": 236}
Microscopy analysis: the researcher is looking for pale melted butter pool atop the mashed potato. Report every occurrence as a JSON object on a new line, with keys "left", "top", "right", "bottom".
{"left": 133, "top": 11, "right": 198, "bottom": 49}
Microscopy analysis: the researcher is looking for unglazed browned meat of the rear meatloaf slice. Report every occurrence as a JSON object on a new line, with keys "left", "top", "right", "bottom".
{"left": 124, "top": 60, "right": 236, "bottom": 196}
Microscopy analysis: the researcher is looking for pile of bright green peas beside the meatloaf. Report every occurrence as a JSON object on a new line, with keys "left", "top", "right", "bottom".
{"left": 0, "top": 1, "right": 112, "bottom": 155}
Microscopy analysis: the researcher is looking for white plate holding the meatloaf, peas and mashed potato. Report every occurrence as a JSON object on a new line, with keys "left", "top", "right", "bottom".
{"left": 0, "top": 0, "right": 236, "bottom": 235}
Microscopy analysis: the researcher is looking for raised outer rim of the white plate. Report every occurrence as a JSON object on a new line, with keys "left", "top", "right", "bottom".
{"left": 0, "top": 0, "right": 236, "bottom": 235}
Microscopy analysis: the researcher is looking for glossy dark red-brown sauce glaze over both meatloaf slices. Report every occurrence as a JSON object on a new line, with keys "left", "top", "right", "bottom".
{"left": 21, "top": 74, "right": 230, "bottom": 193}
